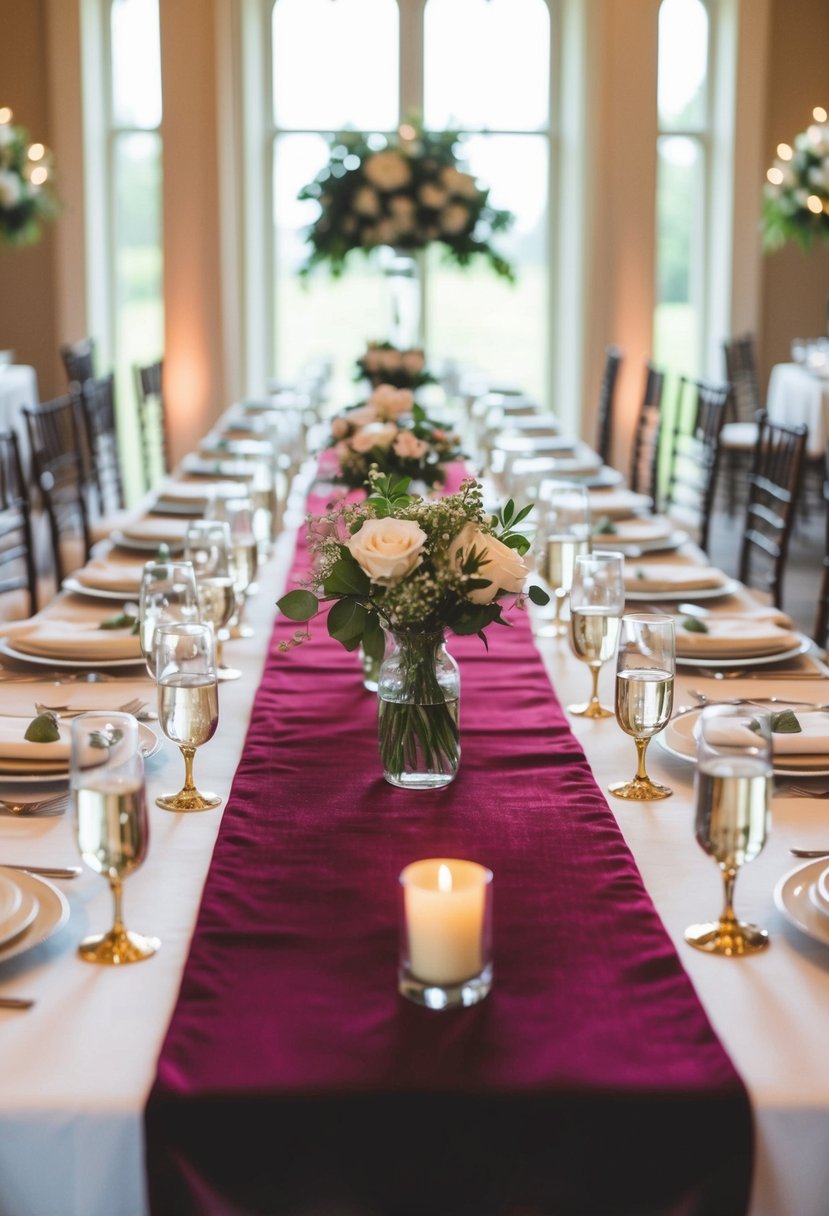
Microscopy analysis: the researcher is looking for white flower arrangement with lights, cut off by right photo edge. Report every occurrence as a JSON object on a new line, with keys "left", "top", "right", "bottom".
{"left": 762, "top": 111, "right": 829, "bottom": 252}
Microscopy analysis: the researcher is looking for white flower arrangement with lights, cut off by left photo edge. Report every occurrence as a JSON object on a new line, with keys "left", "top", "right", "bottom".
{"left": 0, "top": 106, "right": 58, "bottom": 246}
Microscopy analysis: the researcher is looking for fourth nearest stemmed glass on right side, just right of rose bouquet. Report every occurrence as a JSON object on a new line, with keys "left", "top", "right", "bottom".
{"left": 534, "top": 482, "right": 591, "bottom": 637}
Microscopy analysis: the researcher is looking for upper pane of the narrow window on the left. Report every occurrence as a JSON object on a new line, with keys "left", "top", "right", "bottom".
{"left": 111, "top": 0, "right": 162, "bottom": 129}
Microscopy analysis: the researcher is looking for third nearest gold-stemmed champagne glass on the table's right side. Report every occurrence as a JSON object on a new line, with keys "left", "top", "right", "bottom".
{"left": 568, "top": 553, "right": 625, "bottom": 717}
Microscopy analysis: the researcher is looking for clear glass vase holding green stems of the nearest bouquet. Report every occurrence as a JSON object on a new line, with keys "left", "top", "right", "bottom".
{"left": 377, "top": 631, "right": 461, "bottom": 789}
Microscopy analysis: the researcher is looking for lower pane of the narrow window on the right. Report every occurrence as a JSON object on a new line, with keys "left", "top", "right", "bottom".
{"left": 654, "top": 136, "right": 703, "bottom": 376}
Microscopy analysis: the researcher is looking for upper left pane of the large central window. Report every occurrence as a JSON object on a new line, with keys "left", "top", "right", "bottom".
{"left": 272, "top": 0, "right": 399, "bottom": 131}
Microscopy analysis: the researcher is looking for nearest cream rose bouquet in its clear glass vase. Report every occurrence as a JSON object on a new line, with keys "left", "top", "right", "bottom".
{"left": 278, "top": 472, "right": 548, "bottom": 789}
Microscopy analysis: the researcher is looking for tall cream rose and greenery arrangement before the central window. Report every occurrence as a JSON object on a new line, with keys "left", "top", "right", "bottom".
{"left": 299, "top": 123, "right": 513, "bottom": 280}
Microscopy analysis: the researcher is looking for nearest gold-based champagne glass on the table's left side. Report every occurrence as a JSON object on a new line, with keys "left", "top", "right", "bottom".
{"left": 69, "top": 713, "right": 160, "bottom": 966}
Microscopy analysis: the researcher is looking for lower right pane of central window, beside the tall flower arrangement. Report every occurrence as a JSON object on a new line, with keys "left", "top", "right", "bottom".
{"left": 427, "top": 135, "right": 549, "bottom": 400}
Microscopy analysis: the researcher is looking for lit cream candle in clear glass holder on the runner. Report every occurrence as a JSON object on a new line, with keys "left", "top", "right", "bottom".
{"left": 397, "top": 857, "right": 492, "bottom": 1009}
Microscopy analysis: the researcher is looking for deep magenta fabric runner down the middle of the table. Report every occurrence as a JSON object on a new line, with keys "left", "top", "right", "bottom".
{"left": 146, "top": 491, "right": 751, "bottom": 1216}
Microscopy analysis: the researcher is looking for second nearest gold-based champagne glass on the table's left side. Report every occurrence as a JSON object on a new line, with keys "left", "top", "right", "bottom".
{"left": 154, "top": 623, "right": 221, "bottom": 811}
